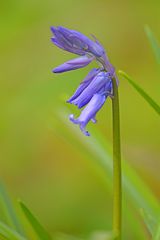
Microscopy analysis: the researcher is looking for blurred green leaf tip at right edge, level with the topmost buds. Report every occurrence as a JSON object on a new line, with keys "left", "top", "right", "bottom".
{"left": 145, "top": 25, "right": 160, "bottom": 64}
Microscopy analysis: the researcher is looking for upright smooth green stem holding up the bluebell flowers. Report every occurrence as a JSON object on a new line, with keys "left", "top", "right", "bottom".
{"left": 112, "top": 78, "right": 122, "bottom": 240}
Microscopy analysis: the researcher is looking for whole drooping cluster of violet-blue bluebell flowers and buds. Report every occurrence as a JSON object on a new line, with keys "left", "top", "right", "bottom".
{"left": 51, "top": 27, "right": 114, "bottom": 136}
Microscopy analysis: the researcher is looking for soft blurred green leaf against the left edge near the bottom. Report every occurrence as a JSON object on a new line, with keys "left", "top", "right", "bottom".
{"left": 0, "top": 183, "right": 25, "bottom": 236}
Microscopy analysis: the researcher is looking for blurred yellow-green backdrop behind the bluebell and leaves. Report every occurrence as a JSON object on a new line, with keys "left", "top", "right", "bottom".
{"left": 0, "top": 0, "right": 160, "bottom": 240}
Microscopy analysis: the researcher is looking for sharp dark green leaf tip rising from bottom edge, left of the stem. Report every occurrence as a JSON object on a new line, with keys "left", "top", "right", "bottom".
{"left": 19, "top": 201, "right": 52, "bottom": 240}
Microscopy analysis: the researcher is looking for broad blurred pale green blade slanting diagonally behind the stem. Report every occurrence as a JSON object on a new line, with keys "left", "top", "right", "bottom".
{"left": 54, "top": 108, "right": 160, "bottom": 239}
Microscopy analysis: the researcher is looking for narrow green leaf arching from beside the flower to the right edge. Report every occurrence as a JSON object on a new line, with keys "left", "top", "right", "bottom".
{"left": 119, "top": 70, "right": 160, "bottom": 115}
